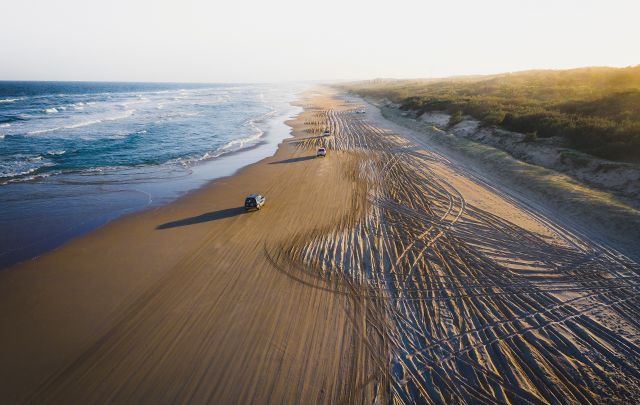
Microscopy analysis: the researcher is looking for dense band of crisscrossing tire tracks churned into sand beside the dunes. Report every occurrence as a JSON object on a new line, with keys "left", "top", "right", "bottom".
{"left": 264, "top": 91, "right": 640, "bottom": 404}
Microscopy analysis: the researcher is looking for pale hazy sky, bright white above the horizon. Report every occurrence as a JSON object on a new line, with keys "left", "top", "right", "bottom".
{"left": 0, "top": 0, "right": 640, "bottom": 83}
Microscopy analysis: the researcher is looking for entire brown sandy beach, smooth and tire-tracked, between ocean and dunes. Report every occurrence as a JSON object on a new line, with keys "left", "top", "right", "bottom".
{"left": 0, "top": 89, "right": 640, "bottom": 404}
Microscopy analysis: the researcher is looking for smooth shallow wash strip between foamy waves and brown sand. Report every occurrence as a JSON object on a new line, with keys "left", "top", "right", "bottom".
{"left": 0, "top": 96, "right": 299, "bottom": 271}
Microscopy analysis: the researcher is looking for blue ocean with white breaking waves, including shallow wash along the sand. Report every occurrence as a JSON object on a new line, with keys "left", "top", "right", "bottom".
{"left": 0, "top": 82, "right": 306, "bottom": 269}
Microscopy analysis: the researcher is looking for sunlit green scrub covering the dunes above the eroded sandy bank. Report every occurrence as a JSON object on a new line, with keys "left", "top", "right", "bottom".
{"left": 343, "top": 65, "right": 640, "bottom": 162}
